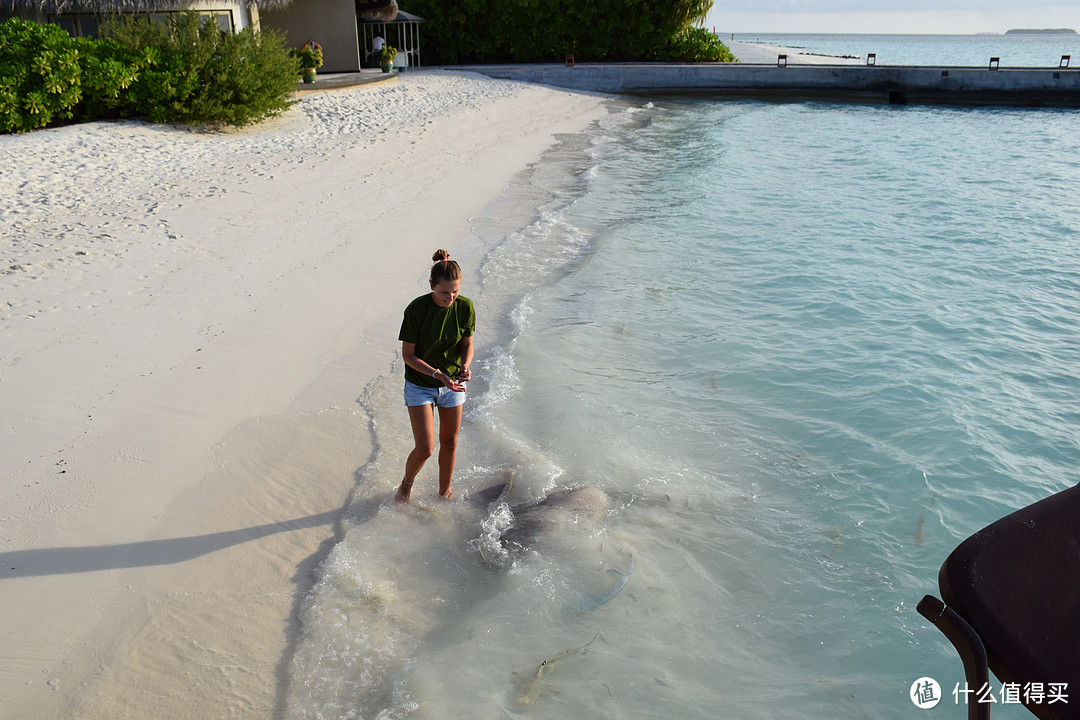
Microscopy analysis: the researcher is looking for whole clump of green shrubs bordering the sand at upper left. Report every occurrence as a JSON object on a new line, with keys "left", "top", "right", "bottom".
{"left": 0, "top": 12, "right": 297, "bottom": 133}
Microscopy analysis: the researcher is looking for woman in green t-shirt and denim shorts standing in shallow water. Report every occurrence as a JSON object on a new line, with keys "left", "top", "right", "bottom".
{"left": 395, "top": 249, "right": 476, "bottom": 503}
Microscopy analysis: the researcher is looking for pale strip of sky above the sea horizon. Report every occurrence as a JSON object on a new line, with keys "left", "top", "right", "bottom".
{"left": 704, "top": 0, "right": 1080, "bottom": 37}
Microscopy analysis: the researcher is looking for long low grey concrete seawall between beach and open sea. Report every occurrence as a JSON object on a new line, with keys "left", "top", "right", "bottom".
{"left": 460, "top": 63, "right": 1080, "bottom": 107}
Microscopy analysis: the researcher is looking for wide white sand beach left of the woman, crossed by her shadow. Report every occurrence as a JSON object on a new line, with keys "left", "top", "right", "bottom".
{"left": 0, "top": 71, "right": 606, "bottom": 720}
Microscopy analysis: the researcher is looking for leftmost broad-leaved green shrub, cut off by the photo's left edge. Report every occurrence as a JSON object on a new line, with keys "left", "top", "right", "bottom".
{"left": 0, "top": 18, "right": 82, "bottom": 133}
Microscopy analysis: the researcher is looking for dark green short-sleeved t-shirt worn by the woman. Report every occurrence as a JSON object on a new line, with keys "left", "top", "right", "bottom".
{"left": 397, "top": 293, "right": 476, "bottom": 388}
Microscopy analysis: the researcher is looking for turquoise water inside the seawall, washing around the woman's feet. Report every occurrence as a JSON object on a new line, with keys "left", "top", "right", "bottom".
{"left": 282, "top": 33, "right": 1080, "bottom": 719}
